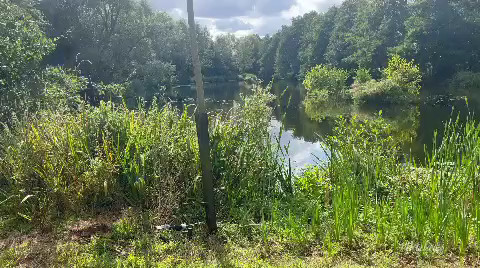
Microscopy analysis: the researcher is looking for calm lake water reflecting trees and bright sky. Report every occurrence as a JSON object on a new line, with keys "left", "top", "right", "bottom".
{"left": 173, "top": 81, "right": 480, "bottom": 172}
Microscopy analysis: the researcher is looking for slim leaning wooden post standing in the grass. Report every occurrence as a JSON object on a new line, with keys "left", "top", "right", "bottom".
{"left": 187, "top": 0, "right": 217, "bottom": 233}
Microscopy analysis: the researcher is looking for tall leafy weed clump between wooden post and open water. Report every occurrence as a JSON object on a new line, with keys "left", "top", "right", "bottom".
{"left": 211, "top": 88, "right": 292, "bottom": 222}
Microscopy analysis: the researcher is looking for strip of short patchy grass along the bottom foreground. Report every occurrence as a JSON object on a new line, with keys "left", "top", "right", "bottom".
{"left": 0, "top": 217, "right": 480, "bottom": 267}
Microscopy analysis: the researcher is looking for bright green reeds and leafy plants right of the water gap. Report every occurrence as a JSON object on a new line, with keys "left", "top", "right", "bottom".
{"left": 284, "top": 112, "right": 480, "bottom": 254}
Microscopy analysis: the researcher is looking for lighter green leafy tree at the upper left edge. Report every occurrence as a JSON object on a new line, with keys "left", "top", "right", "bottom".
{"left": 0, "top": 1, "right": 55, "bottom": 122}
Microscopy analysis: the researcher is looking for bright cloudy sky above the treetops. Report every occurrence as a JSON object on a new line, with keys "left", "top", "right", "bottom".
{"left": 150, "top": 0, "right": 343, "bottom": 36}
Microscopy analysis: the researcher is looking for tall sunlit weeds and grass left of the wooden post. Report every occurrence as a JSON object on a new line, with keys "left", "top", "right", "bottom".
{"left": 0, "top": 100, "right": 198, "bottom": 226}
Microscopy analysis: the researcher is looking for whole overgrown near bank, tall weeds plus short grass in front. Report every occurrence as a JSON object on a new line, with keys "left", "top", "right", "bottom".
{"left": 0, "top": 88, "right": 480, "bottom": 267}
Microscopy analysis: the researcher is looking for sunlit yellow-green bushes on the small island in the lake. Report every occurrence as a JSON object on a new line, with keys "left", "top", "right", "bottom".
{"left": 303, "top": 55, "right": 422, "bottom": 112}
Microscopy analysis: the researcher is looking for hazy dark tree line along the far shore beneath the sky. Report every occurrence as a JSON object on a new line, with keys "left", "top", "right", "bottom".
{"left": 7, "top": 0, "right": 480, "bottom": 103}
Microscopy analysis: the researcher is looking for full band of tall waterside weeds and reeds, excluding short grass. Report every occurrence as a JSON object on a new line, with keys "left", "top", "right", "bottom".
{"left": 4, "top": 80, "right": 480, "bottom": 254}
